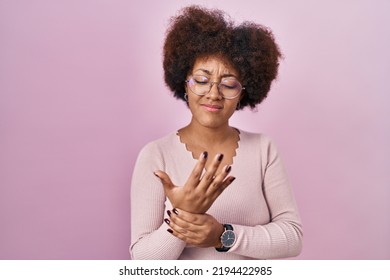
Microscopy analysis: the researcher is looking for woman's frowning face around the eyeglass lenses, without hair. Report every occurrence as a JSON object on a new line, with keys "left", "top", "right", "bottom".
{"left": 185, "top": 56, "right": 242, "bottom": 128}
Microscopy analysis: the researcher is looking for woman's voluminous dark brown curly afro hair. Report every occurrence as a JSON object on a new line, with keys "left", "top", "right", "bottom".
{"left": 163, "top": 6, "right": 281, "bottom": 110}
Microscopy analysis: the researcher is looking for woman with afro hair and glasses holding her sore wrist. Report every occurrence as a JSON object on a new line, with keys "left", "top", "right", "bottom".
{"left": 130, "top": 6, "right": 302, "bottom": 259}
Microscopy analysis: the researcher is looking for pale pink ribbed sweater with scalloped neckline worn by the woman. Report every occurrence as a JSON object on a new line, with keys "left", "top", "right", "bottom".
{"left": 130, "top": 131, "right": 302, "bottom": 259}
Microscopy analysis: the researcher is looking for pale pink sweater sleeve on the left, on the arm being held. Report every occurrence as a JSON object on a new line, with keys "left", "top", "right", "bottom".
{"left": 129, "top": 143, "right": 185, "bottom": 260}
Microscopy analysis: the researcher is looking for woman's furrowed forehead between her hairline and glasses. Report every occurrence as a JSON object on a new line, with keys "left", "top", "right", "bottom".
{"left": 192, "top": 56, "right": 238, "bottom": 77}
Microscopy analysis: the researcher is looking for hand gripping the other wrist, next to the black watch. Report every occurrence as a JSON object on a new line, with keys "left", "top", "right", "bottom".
{"left": 165, "top": 208, "right": 224, "bottom": 248}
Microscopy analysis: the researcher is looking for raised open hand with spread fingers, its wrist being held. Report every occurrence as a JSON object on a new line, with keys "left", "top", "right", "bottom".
{"left": 154, "top": 152, "right": 235, "bottom": 214}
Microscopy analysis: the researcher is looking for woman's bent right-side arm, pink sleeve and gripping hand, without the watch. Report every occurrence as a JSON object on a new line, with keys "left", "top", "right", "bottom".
{"left": 166, "top": 139, "right": 302, "bottom": 259}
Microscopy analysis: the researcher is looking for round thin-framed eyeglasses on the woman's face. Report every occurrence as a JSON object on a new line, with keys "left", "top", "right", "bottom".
{"left": 186, "top": 75, "right": 245, "bottom": 99}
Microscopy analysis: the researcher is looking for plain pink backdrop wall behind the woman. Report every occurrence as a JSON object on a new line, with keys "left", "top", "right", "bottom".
{"left": 0, "top": 0, "right": 390, "bottom": 259}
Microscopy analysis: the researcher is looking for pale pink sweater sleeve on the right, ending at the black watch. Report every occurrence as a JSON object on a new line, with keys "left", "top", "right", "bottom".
{"left": 230, "top": 136, "right": 303, "bottom": 259}
